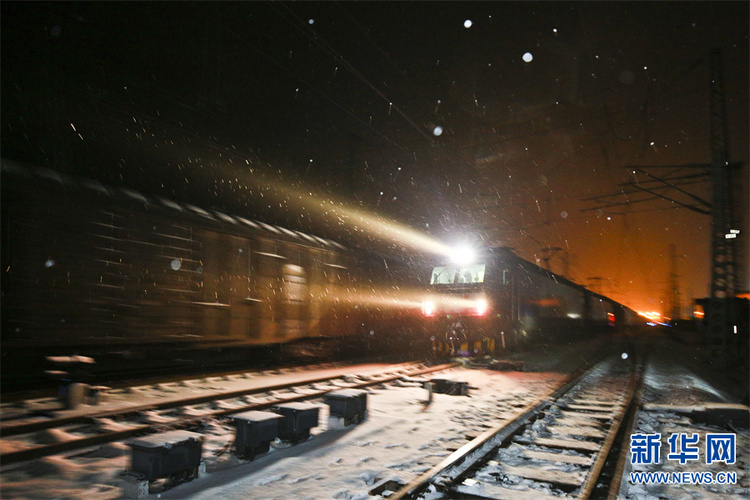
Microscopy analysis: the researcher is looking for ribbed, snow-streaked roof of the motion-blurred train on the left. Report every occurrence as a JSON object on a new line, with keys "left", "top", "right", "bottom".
{"left": 0, "top": 158, "right": 346, "bottom": 250}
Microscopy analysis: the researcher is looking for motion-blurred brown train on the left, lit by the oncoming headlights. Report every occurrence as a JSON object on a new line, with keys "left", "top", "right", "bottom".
{"left": 0, "top": 160, "right": 426, "bottom": 384}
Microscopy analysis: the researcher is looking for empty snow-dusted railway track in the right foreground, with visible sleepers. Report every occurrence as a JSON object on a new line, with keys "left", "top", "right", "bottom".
{"left": 389, "top": 359, "right": 643, "bottom": 500}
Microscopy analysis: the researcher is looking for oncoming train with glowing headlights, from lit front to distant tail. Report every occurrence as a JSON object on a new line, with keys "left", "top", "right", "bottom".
{"left": 422, "top": 247, "right": 637, "bottom": 356}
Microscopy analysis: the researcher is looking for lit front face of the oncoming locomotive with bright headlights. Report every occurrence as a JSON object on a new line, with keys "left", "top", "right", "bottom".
{"left": 422, "top": 248, "right": 498, "bottom": 357}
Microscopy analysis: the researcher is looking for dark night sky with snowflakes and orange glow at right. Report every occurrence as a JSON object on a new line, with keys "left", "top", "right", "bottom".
{"left": 0, "top": 1, "right": 749, "bottom": 310}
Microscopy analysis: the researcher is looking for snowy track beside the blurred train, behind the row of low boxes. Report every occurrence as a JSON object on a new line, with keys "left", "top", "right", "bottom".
{"left": 0, "top": 363, "right": 457, "bottom": 466}
